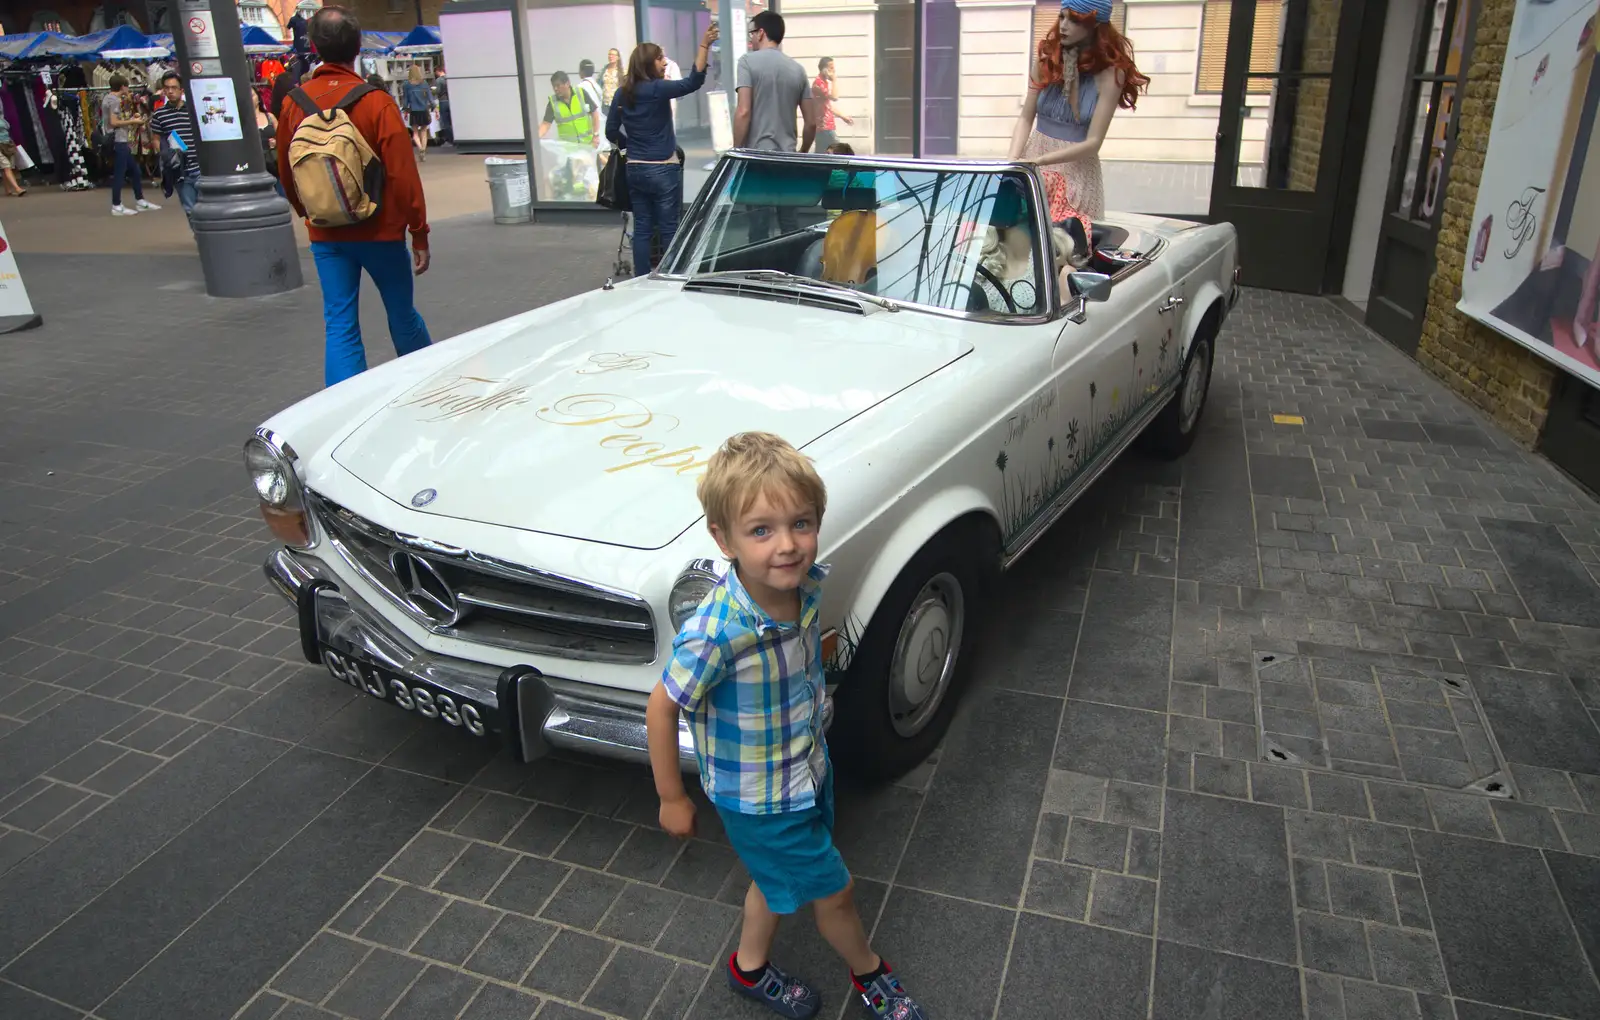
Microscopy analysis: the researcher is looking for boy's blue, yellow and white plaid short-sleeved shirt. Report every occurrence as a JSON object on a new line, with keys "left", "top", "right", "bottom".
{"left": 661, "top": 563, "right": 827, "bottom": 814}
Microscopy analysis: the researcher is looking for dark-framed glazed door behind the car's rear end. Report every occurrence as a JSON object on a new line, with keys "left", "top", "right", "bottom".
{"left": 1206, "top": 0, "right": 1384, "bottom": 294}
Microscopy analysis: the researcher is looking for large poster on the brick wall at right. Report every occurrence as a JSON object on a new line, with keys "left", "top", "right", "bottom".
{"left": 1458, "top": 0, "right": 1600, "bottom": 387}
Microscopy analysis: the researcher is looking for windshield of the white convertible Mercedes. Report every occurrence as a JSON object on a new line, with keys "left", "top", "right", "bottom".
{"left": 664, "top": 157, "right": 1048, "bottom": 317}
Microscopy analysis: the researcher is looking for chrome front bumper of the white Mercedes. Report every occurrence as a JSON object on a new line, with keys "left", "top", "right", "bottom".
{"left": 264, "top": 548, "right": 696, "bottom": 772}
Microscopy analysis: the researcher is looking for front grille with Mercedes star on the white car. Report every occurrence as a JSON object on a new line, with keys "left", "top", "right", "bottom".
{"left": 307, "top": 492, "right": 656, "bottom": 663}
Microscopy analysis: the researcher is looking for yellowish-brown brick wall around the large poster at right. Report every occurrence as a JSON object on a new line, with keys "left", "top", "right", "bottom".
{"left": 1416, "top": 0, "right": 1557, "bottom": 448}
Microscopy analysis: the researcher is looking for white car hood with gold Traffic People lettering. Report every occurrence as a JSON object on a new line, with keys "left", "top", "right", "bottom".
{"left": 333, "top": 285, "right": 971, "bottom": 548}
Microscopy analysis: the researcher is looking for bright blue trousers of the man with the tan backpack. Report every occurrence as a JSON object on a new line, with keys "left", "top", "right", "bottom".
{"left": 310, "top": 241, "right": 434, "bottom": 385}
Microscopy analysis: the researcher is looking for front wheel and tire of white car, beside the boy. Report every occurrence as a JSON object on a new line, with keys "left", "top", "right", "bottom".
{"left": 827, "top": 526, "right": 992, "bottom": 780}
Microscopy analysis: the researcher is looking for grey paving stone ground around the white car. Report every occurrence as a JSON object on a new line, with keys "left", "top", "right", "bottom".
{"left": 0, "top": 217, "right": 1600, "bottom": 1020}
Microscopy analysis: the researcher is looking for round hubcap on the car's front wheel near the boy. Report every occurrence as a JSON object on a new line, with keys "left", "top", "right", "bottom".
{"left": 890, "top": 574, "right": 966, "bottom": 737}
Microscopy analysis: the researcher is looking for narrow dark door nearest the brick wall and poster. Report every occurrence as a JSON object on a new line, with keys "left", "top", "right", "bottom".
{"left": 1366, "top": 0, "right": 1477, "bottom": 357}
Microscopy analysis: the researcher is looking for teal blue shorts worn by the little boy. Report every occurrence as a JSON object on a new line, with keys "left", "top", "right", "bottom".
{"left": 717, "top": 767, "right": 850, "bottom": 914}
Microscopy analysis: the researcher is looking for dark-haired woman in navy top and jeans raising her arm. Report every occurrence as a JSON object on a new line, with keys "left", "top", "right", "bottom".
{"left": 605, "top": 21, "right": 717, "bottom": 277}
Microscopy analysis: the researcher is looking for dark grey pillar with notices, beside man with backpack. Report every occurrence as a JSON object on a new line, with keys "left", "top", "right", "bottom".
{"left": 171, "top": 0, "right": 302, "bottom": 297}
